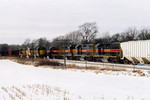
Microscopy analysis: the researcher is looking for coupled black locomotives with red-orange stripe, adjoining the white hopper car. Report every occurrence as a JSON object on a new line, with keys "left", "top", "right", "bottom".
{"left": 48, "top": 42, "right": 121, "bottom": 62}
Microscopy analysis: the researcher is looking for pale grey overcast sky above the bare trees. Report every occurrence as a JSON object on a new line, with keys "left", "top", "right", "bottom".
{"left": 0, "top": 0, "right": 150, "bottom": 44}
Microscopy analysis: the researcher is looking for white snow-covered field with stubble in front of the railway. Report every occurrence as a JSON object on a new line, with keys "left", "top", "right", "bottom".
{"left": 0, "top": 60, "right": 150, "bottom": 100}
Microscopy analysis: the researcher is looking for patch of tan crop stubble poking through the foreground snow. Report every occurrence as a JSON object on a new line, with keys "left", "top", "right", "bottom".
{"left": 0, "top": 84, "right": 73, "bottom": 100}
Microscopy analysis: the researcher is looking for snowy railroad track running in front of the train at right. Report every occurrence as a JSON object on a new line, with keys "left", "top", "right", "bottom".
{"left": 51, "top": 59, "right": 150, "bottom": 71}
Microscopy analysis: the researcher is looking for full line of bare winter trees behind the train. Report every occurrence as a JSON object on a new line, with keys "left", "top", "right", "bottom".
{"left": 0, "top": 22, "right": 150, "bottom": 52}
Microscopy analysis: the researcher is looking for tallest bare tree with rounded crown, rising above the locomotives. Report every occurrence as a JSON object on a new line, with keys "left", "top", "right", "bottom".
{"left": 79, "top": 22, "right": 98, "bottom": 43}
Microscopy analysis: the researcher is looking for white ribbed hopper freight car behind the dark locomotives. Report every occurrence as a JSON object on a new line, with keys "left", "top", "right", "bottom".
{"left": 121, "top": 40, "right": 150, "bottom": 64}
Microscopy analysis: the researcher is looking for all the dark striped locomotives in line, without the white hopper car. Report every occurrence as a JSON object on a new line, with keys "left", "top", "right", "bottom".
{"left": 19, "top": 43, "right": 121, "bottom": 62}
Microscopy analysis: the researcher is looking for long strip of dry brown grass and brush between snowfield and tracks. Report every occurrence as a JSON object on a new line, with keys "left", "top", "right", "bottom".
{"left": 1, "top": 57, "right": 126, "bottom": 74}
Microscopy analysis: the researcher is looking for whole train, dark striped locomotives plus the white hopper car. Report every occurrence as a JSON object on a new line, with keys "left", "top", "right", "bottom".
{"left": 1, "top": 40, "right": 150, "bottom": 64}
